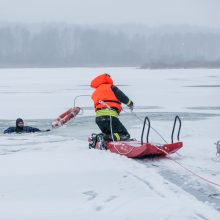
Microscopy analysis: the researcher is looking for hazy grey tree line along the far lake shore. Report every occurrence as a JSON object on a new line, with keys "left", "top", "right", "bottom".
{"left": 0, "top": 24, "right": 220, "bottom": 68}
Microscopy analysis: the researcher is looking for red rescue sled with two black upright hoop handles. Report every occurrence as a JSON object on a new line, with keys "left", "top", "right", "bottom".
{"left": 90, "top": 116, "right": 183, "bottom": 158}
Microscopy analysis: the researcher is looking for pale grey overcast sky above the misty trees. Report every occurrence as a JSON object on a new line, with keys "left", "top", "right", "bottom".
{"left": 0, "top": 0, "right": 220, "bottom": 27}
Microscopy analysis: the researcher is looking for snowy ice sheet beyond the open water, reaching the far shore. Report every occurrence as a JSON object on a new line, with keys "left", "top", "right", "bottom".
{"left": 0, "top": 68, "right": 220, "bottom": 119}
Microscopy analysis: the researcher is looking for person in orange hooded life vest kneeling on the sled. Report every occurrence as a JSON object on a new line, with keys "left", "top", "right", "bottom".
{"left": 90, "top": 73, "right": 134, "bottom": 141}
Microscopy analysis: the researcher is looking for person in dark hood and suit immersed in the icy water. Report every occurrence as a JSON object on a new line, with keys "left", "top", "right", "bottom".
{"left": 4, "top": 118, "right": 50, "bottom": 134}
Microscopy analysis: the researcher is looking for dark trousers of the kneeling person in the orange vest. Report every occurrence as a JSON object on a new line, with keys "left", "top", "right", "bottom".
{"left": 96, "top": 116, "right": 130, "bottom": 141}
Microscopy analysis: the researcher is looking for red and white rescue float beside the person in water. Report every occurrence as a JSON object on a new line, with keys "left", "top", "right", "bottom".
{"left": 51, "top": 107, "right": 80, "bottom": 128}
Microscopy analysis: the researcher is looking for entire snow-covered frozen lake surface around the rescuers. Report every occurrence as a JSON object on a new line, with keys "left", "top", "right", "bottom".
{"left": 0, "top": 68, "right": 220, "bottom": 220}
